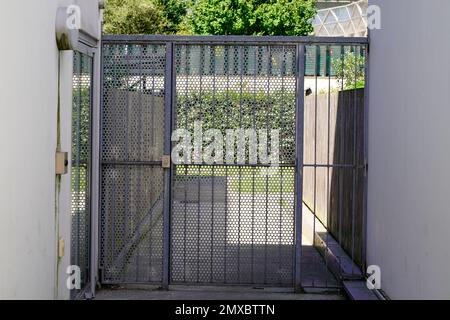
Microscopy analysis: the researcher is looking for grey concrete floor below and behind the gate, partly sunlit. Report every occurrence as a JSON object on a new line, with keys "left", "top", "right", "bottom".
{"left": 97, "top": 188, "right": 343, "bottom": 300}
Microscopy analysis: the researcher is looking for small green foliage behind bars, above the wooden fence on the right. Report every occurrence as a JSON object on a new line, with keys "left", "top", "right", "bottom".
{"left": 331, "top": 51, "right": 366, "bottom": 90}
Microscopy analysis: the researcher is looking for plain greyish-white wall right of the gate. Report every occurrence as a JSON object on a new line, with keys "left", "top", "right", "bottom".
{"left": 367, "top": 0, "right": 450, "bottom": 299}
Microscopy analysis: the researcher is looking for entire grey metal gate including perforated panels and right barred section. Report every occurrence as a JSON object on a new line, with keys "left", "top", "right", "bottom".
{"left": 100, "top": 36, "right": 367, "bottom": 290}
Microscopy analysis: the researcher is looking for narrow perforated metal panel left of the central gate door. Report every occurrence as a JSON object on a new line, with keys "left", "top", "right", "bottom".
{"left": 100, "top": 45, "right": 165, "bottom": 283}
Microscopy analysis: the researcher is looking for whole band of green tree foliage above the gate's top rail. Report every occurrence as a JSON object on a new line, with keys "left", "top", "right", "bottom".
{"left": 104, "top": 0, "right": 316, "bottom": 35}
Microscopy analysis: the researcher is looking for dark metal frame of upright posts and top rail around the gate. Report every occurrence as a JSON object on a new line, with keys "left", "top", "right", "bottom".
{"left": 98, "top": 35, "right": 370, "bottom": 292}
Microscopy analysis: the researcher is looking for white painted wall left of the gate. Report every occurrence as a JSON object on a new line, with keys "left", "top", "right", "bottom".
{"left": 0, "top": 0, "right": 98, "bottom": 299}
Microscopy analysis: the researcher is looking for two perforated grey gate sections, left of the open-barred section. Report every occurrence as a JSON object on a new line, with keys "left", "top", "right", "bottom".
{"left": 100, "top": 36, "right": 370, "bottom": 288}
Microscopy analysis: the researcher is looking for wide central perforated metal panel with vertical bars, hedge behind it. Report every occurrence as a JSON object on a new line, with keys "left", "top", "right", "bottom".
{"left": 171, "top": 45, "right": 296, "bottom": 286}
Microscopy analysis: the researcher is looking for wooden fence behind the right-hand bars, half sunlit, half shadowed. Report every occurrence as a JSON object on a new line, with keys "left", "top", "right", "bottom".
{"left": 303, "top": 89, "right": 365, "bottom": 266}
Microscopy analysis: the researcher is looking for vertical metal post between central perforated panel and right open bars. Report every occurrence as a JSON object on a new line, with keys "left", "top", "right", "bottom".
{"left": 294, "top": 44, "right": 305, "bottom": 292}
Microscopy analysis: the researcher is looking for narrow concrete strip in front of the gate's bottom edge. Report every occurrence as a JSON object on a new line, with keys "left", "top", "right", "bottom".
{"left": 95, "top": 286, "right": 345, "bottom": 300}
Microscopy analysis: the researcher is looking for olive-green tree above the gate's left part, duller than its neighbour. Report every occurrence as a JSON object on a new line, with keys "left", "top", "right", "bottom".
{"left": 104, "top": 0, "right": 187, "bottom": 34}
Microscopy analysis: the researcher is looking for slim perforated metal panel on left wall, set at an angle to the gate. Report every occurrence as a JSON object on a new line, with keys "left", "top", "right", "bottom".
{"left": 70, "top": 51, "right": 93, "bottom": 297}
